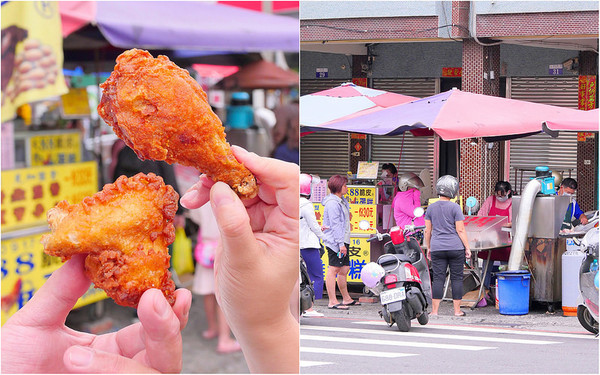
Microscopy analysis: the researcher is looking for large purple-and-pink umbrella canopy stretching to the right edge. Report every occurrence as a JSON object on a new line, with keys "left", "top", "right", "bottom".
{"left": 302, "top": 89, "right": 599, "bottom": 141}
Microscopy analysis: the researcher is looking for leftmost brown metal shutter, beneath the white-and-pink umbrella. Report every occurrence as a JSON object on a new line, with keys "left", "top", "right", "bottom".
{"left": 300, "top": 131, "right": 350, "bottom": 178}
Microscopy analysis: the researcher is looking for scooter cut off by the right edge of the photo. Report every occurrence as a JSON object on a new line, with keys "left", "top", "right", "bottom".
{"left": 560, "top": 211, "right": 599, "bottom": 335}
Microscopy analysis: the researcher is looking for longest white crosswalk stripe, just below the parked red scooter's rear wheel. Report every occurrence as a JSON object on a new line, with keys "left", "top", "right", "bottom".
{"left": 302, "top": 326, "right": 560, "bottom": 345}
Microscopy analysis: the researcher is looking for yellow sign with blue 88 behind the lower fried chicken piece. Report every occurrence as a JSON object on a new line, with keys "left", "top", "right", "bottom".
{"left": 2, "top": 234, "right": 106, "bottom": 324}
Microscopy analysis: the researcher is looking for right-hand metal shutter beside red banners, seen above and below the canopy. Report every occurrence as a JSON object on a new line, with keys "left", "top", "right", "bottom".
{"left": 507, "top": 77, "right": 578, "bottom": 193}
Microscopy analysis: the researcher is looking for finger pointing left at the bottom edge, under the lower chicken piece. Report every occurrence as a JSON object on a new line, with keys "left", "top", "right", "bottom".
{"left": 63, "top": 345, "right": 158, "bottom": 374}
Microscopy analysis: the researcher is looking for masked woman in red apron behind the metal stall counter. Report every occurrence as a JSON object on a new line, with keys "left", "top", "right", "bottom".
{"left": 477, "top": 181, "right": 512, "bottom": 296}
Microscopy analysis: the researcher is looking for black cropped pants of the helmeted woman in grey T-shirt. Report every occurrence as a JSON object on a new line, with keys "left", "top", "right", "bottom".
{"left": 431, "top": 250, "right": 465, "bottom": 299}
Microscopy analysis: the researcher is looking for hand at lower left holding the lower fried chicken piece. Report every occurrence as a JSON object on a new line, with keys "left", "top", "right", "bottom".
{"left": 2, "top": 254, "right": 192, "bottom": 373}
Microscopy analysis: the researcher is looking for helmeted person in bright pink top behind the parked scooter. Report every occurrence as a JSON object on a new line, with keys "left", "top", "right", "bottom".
{"left": 392, "top": 172, "right": 425, "bottom": 228}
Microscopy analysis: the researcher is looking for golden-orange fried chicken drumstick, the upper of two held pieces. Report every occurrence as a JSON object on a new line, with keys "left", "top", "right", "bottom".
{"left": 98, "top": 49, "right": 258, "bottom": 198}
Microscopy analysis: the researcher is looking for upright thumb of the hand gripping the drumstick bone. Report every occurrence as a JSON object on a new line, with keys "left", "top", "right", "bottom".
{"left": 210, "top": 182, "right": 256, "bottom": 260}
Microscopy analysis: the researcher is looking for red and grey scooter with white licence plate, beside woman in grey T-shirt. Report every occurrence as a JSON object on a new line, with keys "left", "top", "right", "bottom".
{"left": 359, "top": 207, "right": 431, "bottom": 332}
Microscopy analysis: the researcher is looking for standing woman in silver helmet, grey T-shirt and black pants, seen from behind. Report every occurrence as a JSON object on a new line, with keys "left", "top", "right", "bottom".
{"left": 425, "top": 175, "right": 471, "bottom": 316}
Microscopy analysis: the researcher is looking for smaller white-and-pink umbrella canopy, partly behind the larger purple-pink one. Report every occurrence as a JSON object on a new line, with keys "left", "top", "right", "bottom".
{"left": 300, "top": 83, "right": 419, "bottom": 127}
